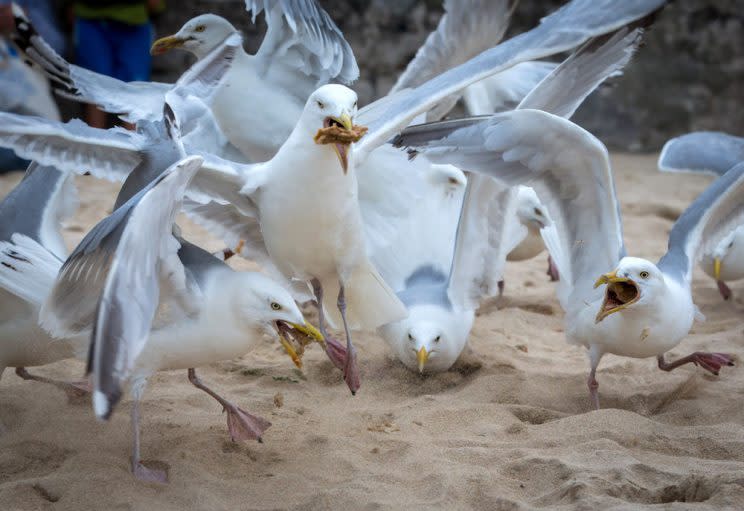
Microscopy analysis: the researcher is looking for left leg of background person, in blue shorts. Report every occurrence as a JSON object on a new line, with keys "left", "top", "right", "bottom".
{"left": 75, "top": 18, "right": 114, "bottom": 128}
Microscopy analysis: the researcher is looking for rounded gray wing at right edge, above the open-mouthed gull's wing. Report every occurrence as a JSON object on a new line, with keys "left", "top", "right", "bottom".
{"left": 659, "top": 131, "right": 744, "bottom": 176}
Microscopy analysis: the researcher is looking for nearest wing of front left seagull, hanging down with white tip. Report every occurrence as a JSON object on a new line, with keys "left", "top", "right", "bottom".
{"left": 84, "top": 156, "right": 202, "bottom": 418}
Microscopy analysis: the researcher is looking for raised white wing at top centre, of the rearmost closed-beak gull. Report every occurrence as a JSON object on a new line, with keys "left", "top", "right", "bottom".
{"left": 245, "top": 0, "right": 359, "bottom": 85}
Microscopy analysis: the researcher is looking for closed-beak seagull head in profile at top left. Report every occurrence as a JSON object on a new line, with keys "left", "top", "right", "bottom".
{"left": 150, "top": 14, "right": 238, "bottom": 58}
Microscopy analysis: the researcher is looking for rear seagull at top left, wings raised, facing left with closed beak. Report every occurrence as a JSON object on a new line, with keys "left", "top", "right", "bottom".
{"left": 14, "top": 0, "right": 359, "bottom": 161}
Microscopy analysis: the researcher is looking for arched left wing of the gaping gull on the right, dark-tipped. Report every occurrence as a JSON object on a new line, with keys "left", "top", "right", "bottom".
{"left": 395, "top": 110, "right": 624, "bottom": 307}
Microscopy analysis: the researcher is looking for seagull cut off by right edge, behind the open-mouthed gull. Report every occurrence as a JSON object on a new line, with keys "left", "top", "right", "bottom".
{"left": 659, "top": 131, "right": 744, "bottom": 300}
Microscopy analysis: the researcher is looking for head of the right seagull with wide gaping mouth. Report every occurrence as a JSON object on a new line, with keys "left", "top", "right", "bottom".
{"left": 594, "top": 257, "right": 666, "bottom": 323}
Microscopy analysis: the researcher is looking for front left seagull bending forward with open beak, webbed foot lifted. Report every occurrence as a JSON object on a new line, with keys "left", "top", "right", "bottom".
{"left": 2, "top": 156, "right": 320, "bottom": 482}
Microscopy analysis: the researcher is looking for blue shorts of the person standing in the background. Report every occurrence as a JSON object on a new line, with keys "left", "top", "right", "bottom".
{"left": 75, "top": 18, "right": 154, "bottom": 82}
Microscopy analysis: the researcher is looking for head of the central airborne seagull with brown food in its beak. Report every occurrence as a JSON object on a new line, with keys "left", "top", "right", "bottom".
{"left": 300, "top": 84, "right": 366, "bottom": 174}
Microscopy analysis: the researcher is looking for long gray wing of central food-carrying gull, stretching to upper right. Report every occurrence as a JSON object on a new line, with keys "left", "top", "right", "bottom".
{"left": 356, "top": 0, "right": 665, "bottom": 157}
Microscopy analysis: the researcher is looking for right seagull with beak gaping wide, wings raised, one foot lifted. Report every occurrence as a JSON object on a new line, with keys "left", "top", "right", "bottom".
{"left": 396, "top": 109, "right": 744, "bottom": 408}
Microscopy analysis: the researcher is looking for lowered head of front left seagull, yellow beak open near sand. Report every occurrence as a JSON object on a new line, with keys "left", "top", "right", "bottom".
{"left": 233, "top": 272, "right": 324, "bottom": 366}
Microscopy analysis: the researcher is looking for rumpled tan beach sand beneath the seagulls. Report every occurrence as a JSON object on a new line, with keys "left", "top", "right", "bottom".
{"left": 0, "top": 155, "right": 744, "bottom": 510}
